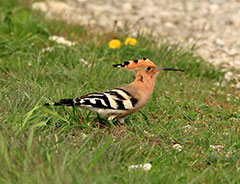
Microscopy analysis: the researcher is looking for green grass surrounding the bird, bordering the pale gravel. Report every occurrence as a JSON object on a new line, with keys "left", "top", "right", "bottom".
{"left": 0, "top": 0, "right": 240, "bottom": 183}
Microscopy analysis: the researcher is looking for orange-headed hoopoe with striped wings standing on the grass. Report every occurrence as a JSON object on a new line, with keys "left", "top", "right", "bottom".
{"left": 45, "top": 58, "right": 184, "bottom": 124}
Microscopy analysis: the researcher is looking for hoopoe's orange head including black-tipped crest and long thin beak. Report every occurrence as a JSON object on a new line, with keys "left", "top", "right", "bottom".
{"left": 113, "top": 58, "right": 184, "bottom": 77}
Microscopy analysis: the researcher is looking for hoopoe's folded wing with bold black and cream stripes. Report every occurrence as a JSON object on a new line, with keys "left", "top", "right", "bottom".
{"left": 74, "top": 88, "right": 138, "bottom": 110}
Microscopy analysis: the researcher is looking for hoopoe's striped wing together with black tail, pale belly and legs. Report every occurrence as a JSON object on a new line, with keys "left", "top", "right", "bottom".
{"left": 44, "top": 88, "right": 138, "bottom": 123}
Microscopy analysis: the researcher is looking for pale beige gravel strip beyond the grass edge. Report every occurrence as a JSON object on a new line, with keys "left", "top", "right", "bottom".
{"left": 32, "top": 0, "right": 240, "bottom": 71}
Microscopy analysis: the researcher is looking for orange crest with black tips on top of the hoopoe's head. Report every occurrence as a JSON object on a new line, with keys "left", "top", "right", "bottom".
{"left": 113, "top": 58, "right": 157, "bottom": 70}
